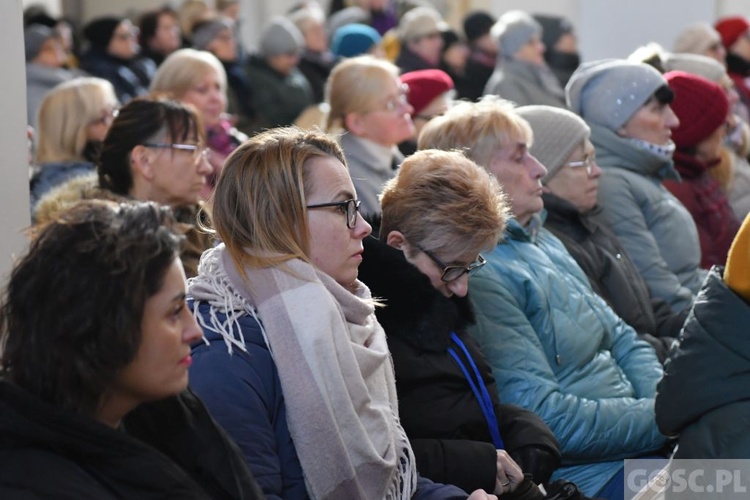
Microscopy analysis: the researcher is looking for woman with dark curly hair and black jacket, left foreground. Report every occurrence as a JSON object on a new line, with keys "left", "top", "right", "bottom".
{"left": 0, "top": 202, "right": 263, "bottom": 500}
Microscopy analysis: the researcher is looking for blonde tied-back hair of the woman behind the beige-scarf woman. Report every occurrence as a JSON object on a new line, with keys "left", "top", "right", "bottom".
{"left": 326, "top": 55, "right": 399, "bottom": 131}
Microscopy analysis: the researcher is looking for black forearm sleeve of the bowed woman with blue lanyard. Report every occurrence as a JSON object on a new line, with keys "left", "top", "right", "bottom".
{"left": 495, "top": 404, "right": 560, "bottom": 483}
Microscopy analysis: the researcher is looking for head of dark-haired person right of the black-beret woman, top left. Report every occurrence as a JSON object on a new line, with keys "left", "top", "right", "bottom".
{"left": 138, "top": 7, "right": 182, "bottom": 67}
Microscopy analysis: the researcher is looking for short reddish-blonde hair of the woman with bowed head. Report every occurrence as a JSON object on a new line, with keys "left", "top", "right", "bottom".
{"left": 380, "top": 149, "right": 509, "bottom": 254}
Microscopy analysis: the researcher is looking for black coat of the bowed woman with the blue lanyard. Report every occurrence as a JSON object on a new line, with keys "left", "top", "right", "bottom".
{"left": 359, "top": 237, "right": 560, "bottom": 492}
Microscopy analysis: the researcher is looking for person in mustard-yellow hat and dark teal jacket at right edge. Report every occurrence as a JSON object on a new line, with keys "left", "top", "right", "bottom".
{"left": 656, "top": 217, "right": 750, "bottom": 459}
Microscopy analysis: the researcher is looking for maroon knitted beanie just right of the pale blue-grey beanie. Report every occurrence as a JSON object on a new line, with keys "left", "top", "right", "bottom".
{"left": 664, "top": 71, "right": 729, "bottom": 149}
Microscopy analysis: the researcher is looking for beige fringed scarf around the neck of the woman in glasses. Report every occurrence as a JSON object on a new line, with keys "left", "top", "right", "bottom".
{"left": 189, "top": 245, "right": 417, "bottom": 500}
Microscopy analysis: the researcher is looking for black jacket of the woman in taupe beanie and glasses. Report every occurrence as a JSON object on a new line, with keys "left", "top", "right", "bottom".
{"left": 542, "top": 193, "right": 687, "bottom": 361}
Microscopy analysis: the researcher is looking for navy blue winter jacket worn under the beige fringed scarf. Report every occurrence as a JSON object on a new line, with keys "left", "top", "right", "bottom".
{"left": 189, "top": 301, "right": 476, "bottom": 500}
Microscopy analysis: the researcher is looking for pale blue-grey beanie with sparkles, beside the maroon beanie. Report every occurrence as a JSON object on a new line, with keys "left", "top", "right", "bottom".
{"left": 565, "top": 59, "right": 667, "bottom": 132}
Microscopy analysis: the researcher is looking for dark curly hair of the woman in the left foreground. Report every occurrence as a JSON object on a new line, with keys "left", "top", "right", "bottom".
{"left": 0, "top": 200, "right": 180, "bottom": 416}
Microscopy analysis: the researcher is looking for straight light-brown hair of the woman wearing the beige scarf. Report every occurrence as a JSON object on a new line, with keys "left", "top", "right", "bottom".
{"left": 208, "top": 127, "right": 346, "bottom": 274}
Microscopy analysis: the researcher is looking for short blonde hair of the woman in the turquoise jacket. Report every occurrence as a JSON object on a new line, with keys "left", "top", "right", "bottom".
{"left": 417, "top": 95, "right": 532, "bottom": 168}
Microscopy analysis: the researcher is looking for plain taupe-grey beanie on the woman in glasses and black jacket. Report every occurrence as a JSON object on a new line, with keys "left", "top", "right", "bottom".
{"left": 516, "top": 106, "right": 591, "bottom": 184}
